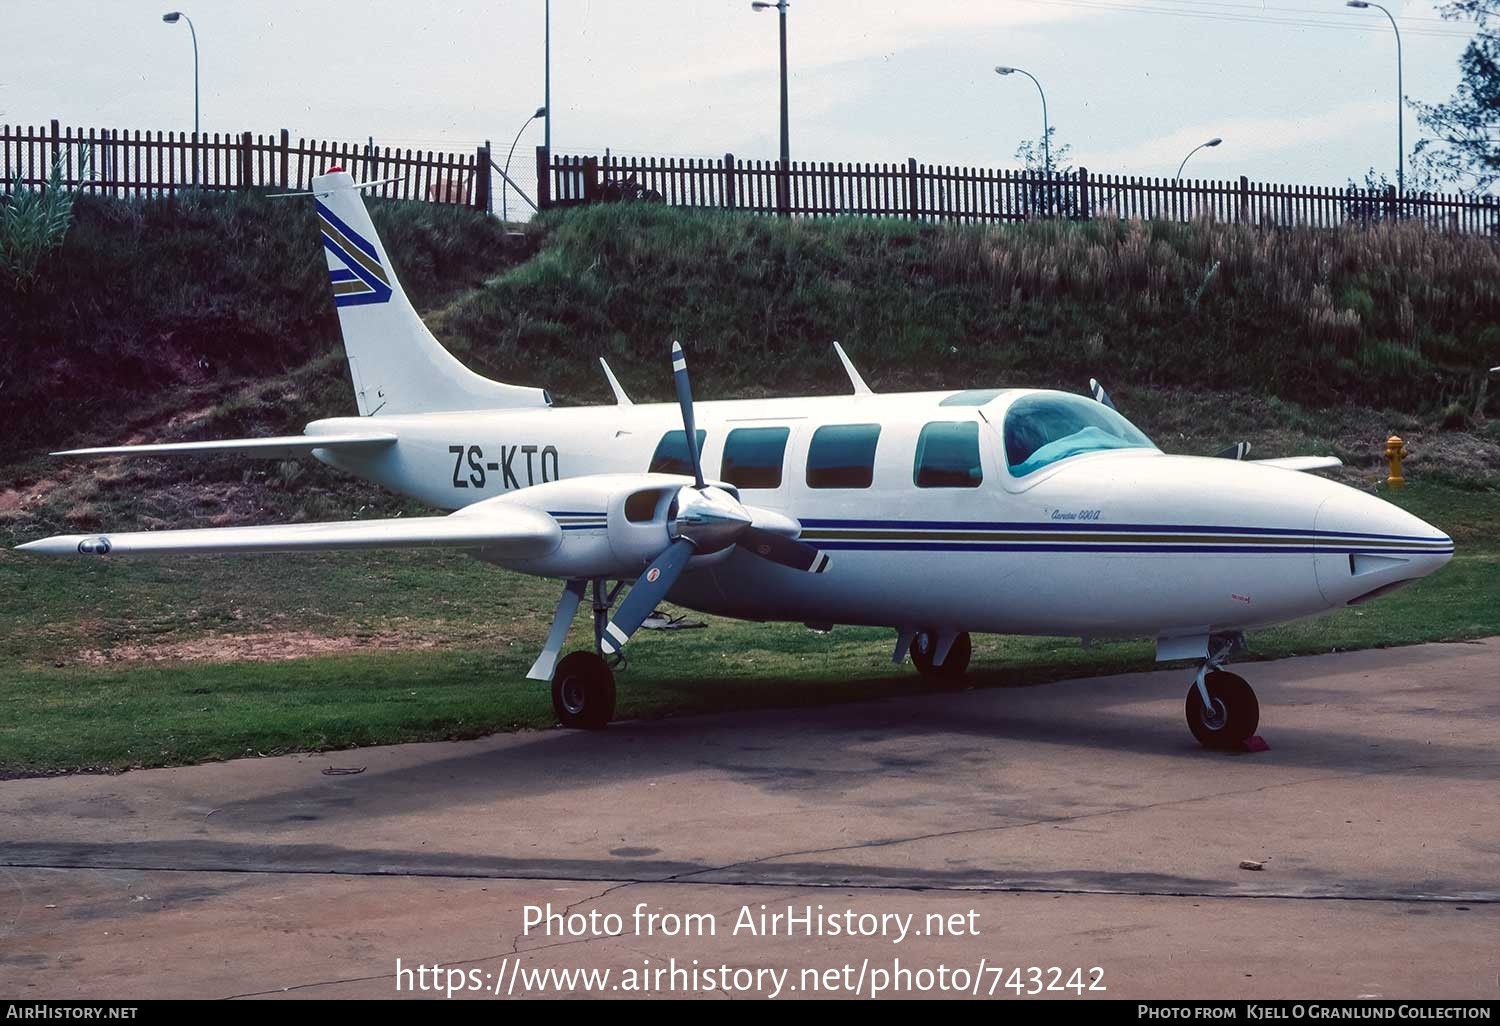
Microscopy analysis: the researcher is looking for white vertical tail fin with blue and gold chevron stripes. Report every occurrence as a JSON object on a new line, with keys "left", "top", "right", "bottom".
{"left": 312, "top": 168, "right": 552, "bottom": 417}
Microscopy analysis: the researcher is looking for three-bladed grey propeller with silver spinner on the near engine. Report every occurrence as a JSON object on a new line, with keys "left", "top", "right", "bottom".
{"left": 599, "top": 342, "right": 828, "bottom": 656}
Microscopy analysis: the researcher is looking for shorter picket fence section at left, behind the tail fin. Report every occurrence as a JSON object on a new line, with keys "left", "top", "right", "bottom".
{"left": 0, "top": 122, "right": 491, "bottom": 210}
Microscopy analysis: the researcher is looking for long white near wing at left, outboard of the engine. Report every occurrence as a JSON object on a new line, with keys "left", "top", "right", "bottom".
{"left": 17, "top": 504, "right": 563, "bottom": 560}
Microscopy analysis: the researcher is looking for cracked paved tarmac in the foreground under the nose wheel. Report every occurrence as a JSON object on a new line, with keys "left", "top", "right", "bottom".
{"left": 0, "top": 639, "right": 1500, "bottom": 999}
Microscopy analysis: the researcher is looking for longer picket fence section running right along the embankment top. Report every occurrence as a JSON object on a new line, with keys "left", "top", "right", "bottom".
{"left": 537, "top": 147, "right": 1500, "bottom": 234}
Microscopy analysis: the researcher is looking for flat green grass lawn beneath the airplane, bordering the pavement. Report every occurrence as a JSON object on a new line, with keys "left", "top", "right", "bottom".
{"left": 0, "top": 486, "right": 1500, "bottom": 776}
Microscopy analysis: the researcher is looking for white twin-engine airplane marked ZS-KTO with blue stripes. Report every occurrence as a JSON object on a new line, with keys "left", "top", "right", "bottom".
{"left": 21, "top": 168, "right": 1454, "bottom": 749}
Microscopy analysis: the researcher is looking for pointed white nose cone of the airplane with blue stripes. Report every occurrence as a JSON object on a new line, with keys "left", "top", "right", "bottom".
{"left": 1313, "top": 486, "right": 1454, "bottom": 606}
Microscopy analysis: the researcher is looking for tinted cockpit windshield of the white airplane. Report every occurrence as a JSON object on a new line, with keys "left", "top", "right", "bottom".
{"left": 1005, "top": 393, "right": 1155, "bottom": 477}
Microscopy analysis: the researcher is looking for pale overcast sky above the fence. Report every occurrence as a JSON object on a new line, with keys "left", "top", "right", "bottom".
{"left": 0, "top": 0, "right": 1469, "bottom": 211}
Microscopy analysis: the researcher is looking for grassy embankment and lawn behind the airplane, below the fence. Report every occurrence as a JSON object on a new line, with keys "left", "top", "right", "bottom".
{"left": 0, "top": 198, "right": 1500, "bottom": 773}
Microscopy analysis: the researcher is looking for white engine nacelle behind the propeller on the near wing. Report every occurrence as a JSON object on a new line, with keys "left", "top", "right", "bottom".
{"left": 456, "top": 474, "right": 735, "bottom": 581}
